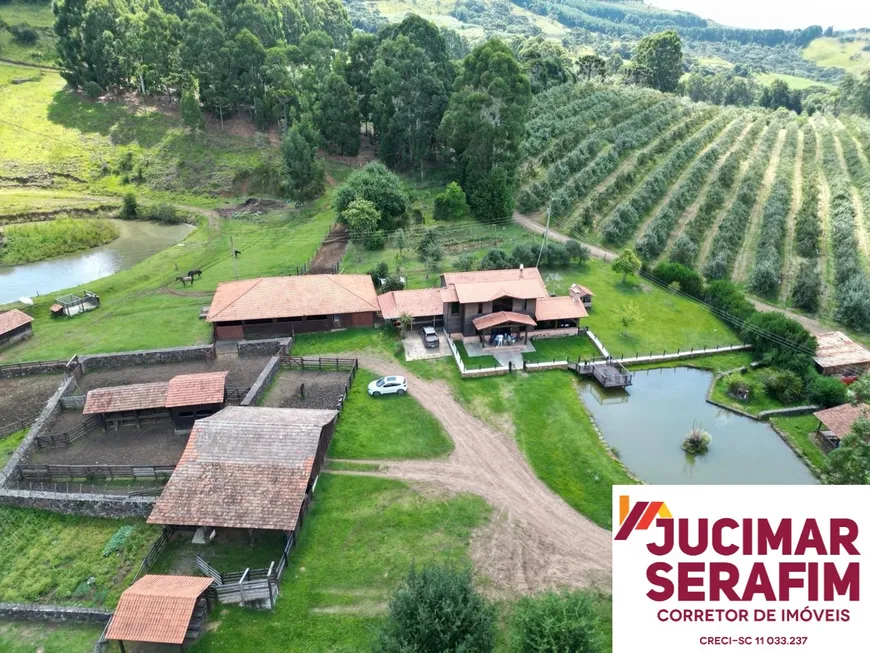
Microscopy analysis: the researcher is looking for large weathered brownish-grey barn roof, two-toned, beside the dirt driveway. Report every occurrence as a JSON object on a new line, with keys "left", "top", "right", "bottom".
{"left": 148, "top": 406, "right": 338, "bottom": 531}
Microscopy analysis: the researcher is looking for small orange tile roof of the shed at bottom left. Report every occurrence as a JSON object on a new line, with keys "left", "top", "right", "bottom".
{"left": 106, "top": 575, "right": 214, "bottom": 644}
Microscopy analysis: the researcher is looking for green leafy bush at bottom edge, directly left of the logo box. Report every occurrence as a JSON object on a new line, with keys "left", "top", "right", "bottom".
{"left": 511, "top": 592, "right": 603, "bottom": 653}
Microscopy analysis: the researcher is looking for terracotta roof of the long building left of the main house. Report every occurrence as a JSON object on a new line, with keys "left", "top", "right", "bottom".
{"left": 206, "top": 274, "right": 380, "bottom": 322}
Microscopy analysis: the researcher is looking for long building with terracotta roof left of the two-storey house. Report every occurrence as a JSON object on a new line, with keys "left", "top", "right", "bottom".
{"left": 206, "top": 274, "right": 380, "bottom": 340}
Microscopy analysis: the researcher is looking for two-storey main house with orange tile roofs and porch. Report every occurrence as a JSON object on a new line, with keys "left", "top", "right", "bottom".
{"left": 378, "top": 266, "right": 591, "bottom": 343}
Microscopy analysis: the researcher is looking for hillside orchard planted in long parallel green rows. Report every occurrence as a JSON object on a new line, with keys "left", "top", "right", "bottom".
{"left": 517, "top": 84, "right": 870, "bottom": 330}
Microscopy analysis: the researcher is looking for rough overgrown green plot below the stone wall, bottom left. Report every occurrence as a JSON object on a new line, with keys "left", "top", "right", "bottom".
{"left": 0, "top": 506, "right": 160, "bottom": 607}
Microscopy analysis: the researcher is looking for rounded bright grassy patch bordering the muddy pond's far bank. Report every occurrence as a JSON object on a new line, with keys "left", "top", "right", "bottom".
{"left": 0, "top": 218, "right": 119, "bottom": 266}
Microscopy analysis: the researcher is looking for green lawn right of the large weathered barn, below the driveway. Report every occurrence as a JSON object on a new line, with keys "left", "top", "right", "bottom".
{"left": 191, "top": 474, "right": 489, "bottom": 653}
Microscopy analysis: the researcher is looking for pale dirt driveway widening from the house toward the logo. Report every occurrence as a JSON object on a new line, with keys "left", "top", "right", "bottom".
{"left": 332, "top": 354, "right": 611, "bottom": 596}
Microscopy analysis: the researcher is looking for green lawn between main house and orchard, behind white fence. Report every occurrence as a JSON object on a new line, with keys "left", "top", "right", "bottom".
{"left": 544, "top": 260, "right": 740, "bottom": 357}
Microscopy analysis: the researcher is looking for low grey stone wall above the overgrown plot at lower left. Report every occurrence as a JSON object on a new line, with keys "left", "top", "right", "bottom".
{"left": 0, "top": 489, "right": 157, "bottom": 519}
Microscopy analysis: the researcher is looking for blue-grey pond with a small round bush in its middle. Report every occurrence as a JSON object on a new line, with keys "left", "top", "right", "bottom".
{"left": 580, "top": 367, "right": 818, "bottom": 485}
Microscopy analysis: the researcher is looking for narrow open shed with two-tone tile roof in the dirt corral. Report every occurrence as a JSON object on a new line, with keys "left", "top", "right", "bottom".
{"left": 82, "top": 372, "right": 229, "bottom": 430}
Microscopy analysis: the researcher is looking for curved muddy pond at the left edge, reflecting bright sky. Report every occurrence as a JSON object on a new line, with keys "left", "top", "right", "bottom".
{"left": 0, "top": 220, "right": 193, "bottom": 304}
